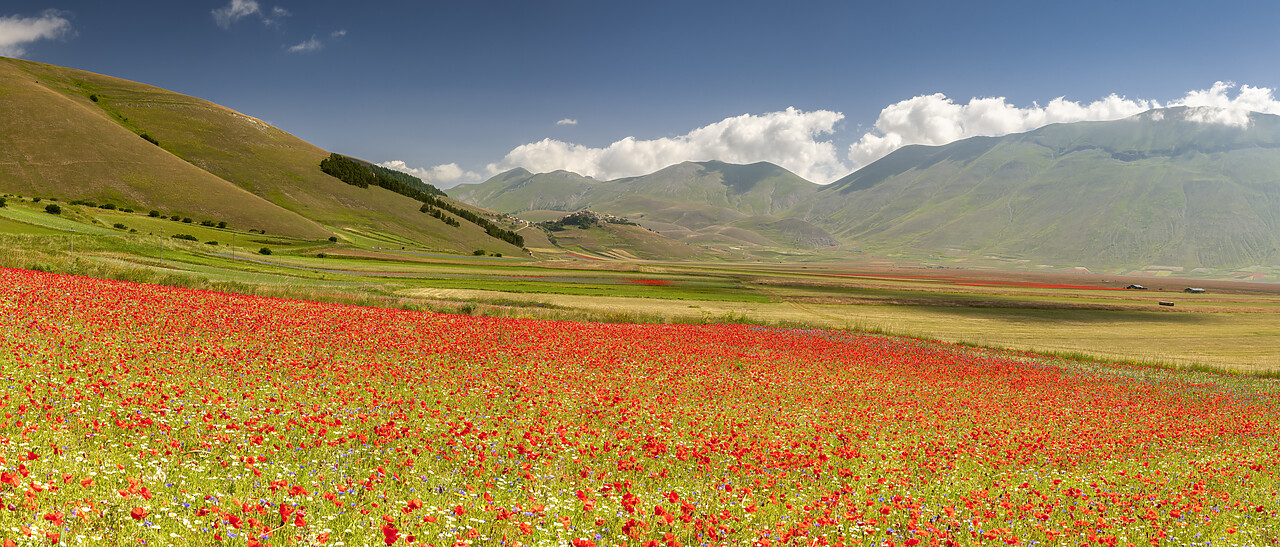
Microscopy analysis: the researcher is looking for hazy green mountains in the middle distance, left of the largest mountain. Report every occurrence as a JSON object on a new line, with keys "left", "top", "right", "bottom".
{"left": 451, "top": 161, "right": 838, "bottom": 249}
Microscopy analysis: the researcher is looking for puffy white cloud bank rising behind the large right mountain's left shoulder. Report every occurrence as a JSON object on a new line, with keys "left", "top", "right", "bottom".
{"left": 849, "top": 94, "right": 1160, "bottom": 167}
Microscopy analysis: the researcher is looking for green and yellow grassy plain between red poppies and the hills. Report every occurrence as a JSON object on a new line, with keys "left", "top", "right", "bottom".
{"left": 0, "top": 197, "right": 1280, "bottom": 374}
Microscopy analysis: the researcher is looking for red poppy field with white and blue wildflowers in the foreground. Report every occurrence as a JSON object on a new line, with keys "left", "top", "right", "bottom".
{"left": 0, "top": 269, "right": 1280, "bottom": 547}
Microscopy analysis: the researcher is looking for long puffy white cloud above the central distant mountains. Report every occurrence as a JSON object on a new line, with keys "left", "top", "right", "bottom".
{"left": 486, "top": 108, "right": 849, "bottom": 182}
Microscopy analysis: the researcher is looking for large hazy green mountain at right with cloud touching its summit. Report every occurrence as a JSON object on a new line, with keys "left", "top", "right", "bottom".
{"left": 804, "top": 108, "right": 1280, "bottom": 268}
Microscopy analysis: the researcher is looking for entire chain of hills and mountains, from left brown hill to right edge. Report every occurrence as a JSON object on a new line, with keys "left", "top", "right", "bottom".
{"left": 0, "top": 58, "right": 1280, "bottom": 269}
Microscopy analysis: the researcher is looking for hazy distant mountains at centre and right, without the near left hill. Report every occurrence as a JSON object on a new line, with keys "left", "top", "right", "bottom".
{"left": 451, "top": 108, "right": 1280, "bottom": 269}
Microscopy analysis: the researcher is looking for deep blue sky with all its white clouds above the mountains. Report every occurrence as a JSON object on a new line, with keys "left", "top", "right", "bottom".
{"left": 0, "top": 0, "right": 1280, "bottom": 186}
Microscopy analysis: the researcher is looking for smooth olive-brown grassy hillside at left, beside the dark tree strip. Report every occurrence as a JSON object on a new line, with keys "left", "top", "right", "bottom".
{"left": 0, "top": 58, "right": 521, "bottom": 254}
